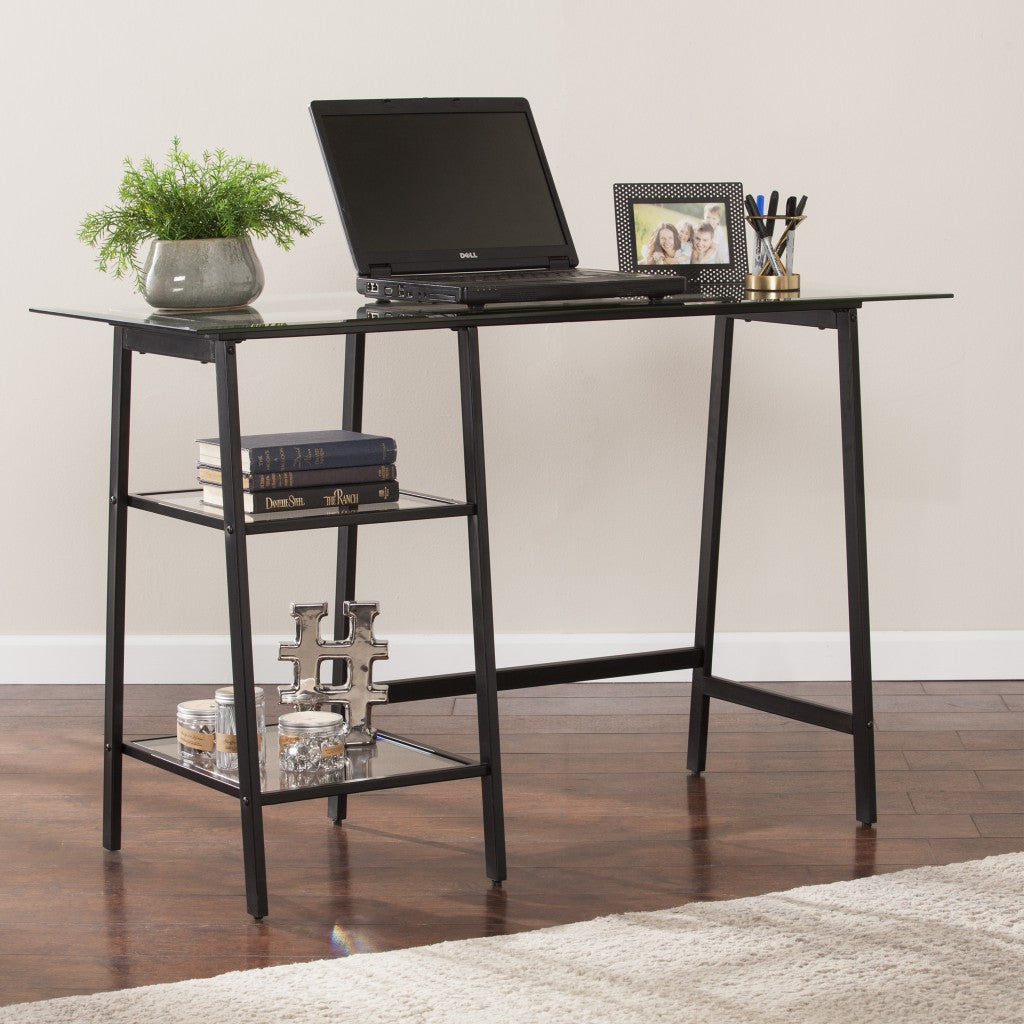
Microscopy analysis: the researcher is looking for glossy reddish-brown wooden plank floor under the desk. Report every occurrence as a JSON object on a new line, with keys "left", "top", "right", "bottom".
{"left": 0, "top": 682, "right": 1024, "bottom": 1004}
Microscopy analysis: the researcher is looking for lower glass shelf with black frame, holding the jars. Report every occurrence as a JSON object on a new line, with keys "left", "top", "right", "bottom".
{"left": 124, "top": 725, "right": 489, "bottom": 804}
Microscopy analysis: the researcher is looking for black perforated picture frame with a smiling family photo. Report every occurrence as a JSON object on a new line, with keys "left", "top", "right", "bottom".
{"left": 613, "top": 181, "right": 748, "bottom": 291}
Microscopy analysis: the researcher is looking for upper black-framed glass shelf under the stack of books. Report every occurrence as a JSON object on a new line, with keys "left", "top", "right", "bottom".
{"left": 128, "top": 489, "right": 476, "bottom": 534}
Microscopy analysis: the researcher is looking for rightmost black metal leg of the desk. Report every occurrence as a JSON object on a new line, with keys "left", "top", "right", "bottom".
{"left": 836, "top": 309, "right": 878, "bottom": 824}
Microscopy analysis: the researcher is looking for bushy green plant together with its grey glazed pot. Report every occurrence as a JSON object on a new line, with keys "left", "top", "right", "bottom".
{"left": 78, "top": 137, "right": 323, "bottom": 309}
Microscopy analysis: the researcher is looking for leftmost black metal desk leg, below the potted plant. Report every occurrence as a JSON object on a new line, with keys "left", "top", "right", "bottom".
{"left": 103, "top": 328, "right": 131, "bottom": 850}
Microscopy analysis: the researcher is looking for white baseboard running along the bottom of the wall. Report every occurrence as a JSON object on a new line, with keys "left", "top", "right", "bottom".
{"left": 0, "top": 630, "right": 1024, "bottom": 685}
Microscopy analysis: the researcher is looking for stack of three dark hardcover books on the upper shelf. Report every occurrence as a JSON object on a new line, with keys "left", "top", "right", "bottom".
{"left": 197, "top": 430, "right": 398, "bottom": 516}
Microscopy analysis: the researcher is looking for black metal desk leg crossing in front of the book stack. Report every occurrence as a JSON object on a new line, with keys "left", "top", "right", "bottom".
{"left": 216, "top": 341, "right": 267, "bottom": 921}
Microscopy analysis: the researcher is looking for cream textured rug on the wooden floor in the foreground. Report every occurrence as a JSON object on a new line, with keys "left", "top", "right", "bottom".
{"left": 0, "top": 853, "right": 1024, "bottom": 1024}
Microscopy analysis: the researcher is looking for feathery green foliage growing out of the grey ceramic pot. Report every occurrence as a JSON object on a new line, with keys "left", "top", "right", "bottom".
{"left": 78, "top": 136, "right": 324, "bottom": 291}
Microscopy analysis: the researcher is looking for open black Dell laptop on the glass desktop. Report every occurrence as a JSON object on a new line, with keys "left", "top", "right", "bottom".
{"left": 309, "top": 98, "right": 692, "bottom": 306}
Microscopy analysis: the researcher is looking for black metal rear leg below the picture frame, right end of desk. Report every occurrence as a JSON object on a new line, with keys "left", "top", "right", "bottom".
{"left": 686, "top": 316, "right": 733, "bottom": 772}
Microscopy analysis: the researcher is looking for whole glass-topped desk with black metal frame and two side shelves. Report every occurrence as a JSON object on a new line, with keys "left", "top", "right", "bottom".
{"left": 37, "top": 295, "right": 944, "bottom": 920}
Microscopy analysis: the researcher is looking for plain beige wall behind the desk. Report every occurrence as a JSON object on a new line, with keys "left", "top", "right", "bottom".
{"left": 0, "top": 0, "right": 1024, "bottom": 651}
